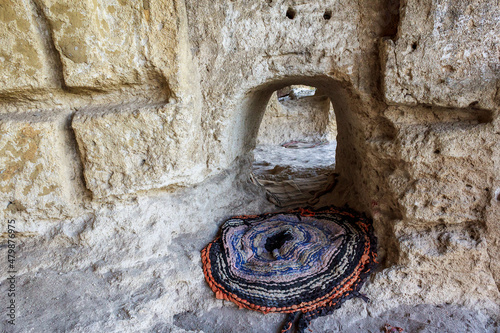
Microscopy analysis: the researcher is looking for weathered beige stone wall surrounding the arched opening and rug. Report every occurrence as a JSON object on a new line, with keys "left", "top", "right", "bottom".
{"left": 0, "top": 0, "right": 500, "bottom": 332}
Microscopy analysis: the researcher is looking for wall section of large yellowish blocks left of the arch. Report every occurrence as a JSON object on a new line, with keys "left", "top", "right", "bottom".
{"left": 0, "top": 1, "right": 207, "bottom": 208}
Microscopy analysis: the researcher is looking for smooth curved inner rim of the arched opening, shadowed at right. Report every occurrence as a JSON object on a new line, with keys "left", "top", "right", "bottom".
{"left": 227, "top": 76, "right": 363, "bottom": 207}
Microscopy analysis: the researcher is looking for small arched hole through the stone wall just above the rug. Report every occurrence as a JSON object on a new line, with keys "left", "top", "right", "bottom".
{"left": 252, "top": 85, "right": 337, "bottom": 207}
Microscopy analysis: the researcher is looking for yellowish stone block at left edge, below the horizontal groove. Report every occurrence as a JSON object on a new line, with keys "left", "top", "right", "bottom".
{"left": 0, "top": 114, "right": 73, "bottom": 219}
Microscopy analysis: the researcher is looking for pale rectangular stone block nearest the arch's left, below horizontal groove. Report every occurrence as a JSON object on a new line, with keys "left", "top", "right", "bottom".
{"left": 72, "top": 104, "right": 206, "bottom": 198}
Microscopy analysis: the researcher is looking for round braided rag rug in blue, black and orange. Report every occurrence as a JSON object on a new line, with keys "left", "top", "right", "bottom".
{"left": 201, "top": 207, "right": 377, "bottom": 332}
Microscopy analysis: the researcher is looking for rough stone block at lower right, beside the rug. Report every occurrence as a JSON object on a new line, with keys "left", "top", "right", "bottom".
{"left": 365, "top": 221, "right": 500, "bottom": 316}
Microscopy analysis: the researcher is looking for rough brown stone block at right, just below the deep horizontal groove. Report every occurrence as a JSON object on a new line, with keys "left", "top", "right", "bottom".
{"left": 389, "top": 124, "right": 496, "bottom": 223}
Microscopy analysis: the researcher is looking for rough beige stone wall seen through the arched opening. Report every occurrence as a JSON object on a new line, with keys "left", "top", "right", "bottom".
{"left": 257, "top": 93, "right": 336, "bottom": 145}
